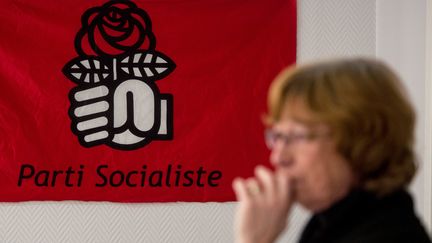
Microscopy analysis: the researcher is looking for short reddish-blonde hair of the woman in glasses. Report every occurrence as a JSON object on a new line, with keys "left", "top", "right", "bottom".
{"left": 266, "top": 58, "right": 416, "bottom": 195}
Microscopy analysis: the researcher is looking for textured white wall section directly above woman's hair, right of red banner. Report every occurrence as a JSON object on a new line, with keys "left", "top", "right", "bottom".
{"left": 297, "top": 0, "right": 376, "bottom": 61}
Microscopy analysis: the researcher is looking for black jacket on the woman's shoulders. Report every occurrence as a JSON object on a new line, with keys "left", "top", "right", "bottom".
{"left": 300, "top": 191, "right": 431, "bottom": 243}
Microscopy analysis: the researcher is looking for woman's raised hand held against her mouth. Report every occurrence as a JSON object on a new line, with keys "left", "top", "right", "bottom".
{"left": 233, "top": 166, "right": 292, "bottom": 243}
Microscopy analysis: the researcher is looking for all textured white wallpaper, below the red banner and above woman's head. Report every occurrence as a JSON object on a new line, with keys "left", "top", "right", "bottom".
{"left": 0, "top": 0, "right": 375, "bottom": 243}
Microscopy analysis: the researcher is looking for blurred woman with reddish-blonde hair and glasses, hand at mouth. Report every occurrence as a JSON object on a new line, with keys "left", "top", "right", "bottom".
{"left": 233, "top": 59, "right": 431, "bottom": 243}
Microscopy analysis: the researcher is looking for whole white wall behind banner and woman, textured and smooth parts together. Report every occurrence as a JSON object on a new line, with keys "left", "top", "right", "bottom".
{"left": 0, "top": 0, "right": 431, "bottom": 243}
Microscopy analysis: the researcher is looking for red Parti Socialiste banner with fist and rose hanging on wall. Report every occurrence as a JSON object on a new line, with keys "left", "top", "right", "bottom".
{"left": 0, "top": 0, "right": 296, "bottom": 202}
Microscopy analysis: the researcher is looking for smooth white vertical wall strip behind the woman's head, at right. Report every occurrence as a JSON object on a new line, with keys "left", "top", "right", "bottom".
{"left": 376, "top": 0, "right": 432, "bottom": 231}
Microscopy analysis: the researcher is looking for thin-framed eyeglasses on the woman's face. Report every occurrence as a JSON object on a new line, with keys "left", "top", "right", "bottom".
{"left": 264, "top": 129, "right": 327, "bottom": 149}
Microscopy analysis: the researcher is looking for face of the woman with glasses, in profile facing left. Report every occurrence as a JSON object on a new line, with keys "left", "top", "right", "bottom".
{"left": 270, "top": 113, "right": 354, "bottom": 212}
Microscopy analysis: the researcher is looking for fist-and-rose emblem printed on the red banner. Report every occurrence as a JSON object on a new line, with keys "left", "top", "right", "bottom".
{"left": 63, "top": 0, "right": 175, "bottom": 150}
